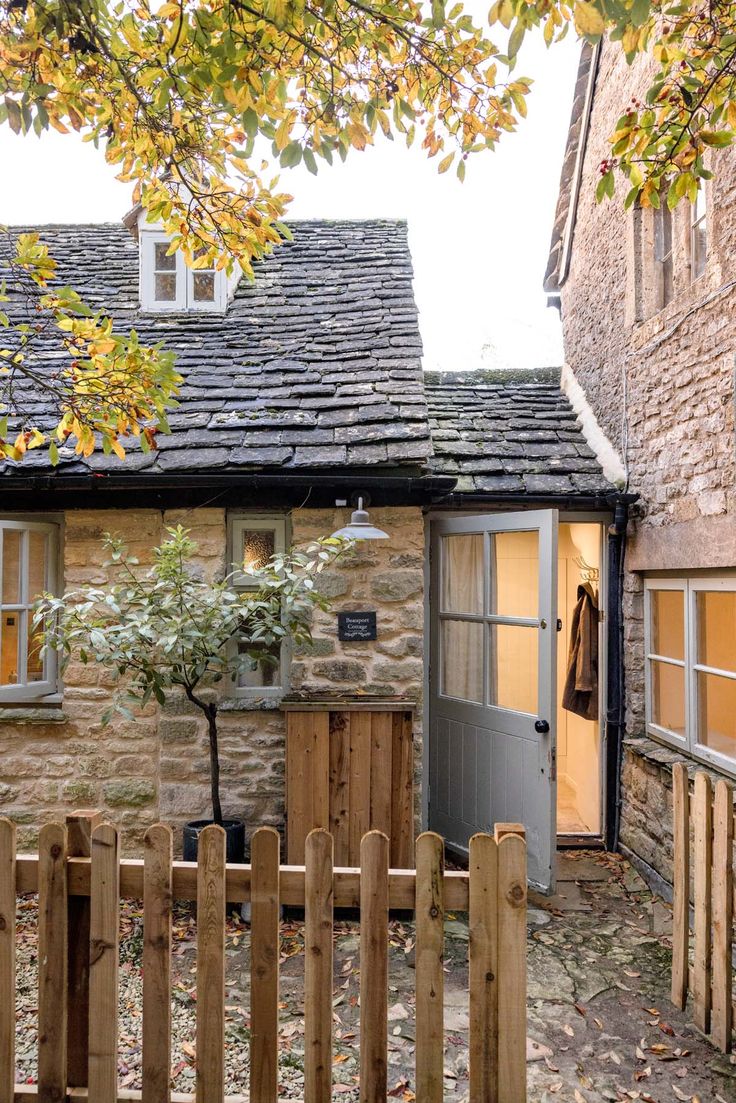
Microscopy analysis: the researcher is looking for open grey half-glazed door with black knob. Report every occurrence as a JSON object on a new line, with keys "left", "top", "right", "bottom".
{"left": 429, "top": 510, "right": 557, "bottom": 891}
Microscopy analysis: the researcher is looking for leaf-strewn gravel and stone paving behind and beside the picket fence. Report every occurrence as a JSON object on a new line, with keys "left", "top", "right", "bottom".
{"left": 10, "top": 853, "right": 736, "bottom": 1103}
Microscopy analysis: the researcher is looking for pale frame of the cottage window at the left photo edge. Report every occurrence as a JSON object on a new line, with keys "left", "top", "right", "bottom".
{"left": 0, "top": 518, "right": 60, "bottom": 706}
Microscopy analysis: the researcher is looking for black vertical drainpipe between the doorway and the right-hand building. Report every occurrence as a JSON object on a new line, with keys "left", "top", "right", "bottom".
{"left": 606, "top": 499, "right": 628, "bottom": 850}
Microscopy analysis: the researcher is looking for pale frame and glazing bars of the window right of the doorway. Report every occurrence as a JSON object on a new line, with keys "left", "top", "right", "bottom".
{"left": 644, "top": 576, "right": 736, "bottom": 778}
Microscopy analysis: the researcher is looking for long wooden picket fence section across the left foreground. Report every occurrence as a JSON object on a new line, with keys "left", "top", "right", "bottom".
{"left": 0, "top": 812, "right": 526, "bottom": 1103}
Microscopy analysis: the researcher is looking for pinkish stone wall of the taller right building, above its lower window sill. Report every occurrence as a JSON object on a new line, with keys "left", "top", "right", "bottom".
{"left": 562, "top": 38, "right": 736, "bottom": 735}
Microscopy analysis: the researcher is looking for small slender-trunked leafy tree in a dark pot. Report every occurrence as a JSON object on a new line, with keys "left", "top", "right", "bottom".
{"left": 34, "top": 525, "right": 345, "bottom": 861}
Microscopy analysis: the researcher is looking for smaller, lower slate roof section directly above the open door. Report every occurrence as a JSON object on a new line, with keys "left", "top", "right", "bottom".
{"left": 425, "top": 368, "right": 616, "bottom": 497}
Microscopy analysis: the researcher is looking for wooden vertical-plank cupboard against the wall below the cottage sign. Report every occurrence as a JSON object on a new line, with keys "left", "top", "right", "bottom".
{"left": 286, "top": 705, "right": 414, "bottom": 869}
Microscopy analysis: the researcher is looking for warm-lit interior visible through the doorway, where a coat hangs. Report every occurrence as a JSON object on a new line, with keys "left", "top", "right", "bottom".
{"left": 557, "top": 522, "right": 605, "bottom": 843}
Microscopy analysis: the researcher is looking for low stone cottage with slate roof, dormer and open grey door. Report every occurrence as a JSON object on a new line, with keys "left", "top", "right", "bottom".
{"left": 0, "top": 212, "right": 628, "bottom": 887}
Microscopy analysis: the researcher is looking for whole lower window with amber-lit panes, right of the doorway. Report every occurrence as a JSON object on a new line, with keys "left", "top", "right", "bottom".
{"left": 644, "top": 577, "right": 736, "bottom": 774}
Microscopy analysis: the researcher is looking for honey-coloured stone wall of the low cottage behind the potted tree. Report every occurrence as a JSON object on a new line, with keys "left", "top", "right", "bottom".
{"left": 0, "top": 508, "right": 424, "bottom": 848}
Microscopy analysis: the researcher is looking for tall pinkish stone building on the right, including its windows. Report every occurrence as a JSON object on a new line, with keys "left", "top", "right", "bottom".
{"left": 545, "top": 44, "right": 736, "bottom": 880}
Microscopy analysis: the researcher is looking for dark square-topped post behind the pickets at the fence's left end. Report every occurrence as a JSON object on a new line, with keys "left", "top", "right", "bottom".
{"left": 66, "top": 808, "right": 103, "bottom": 1088}
